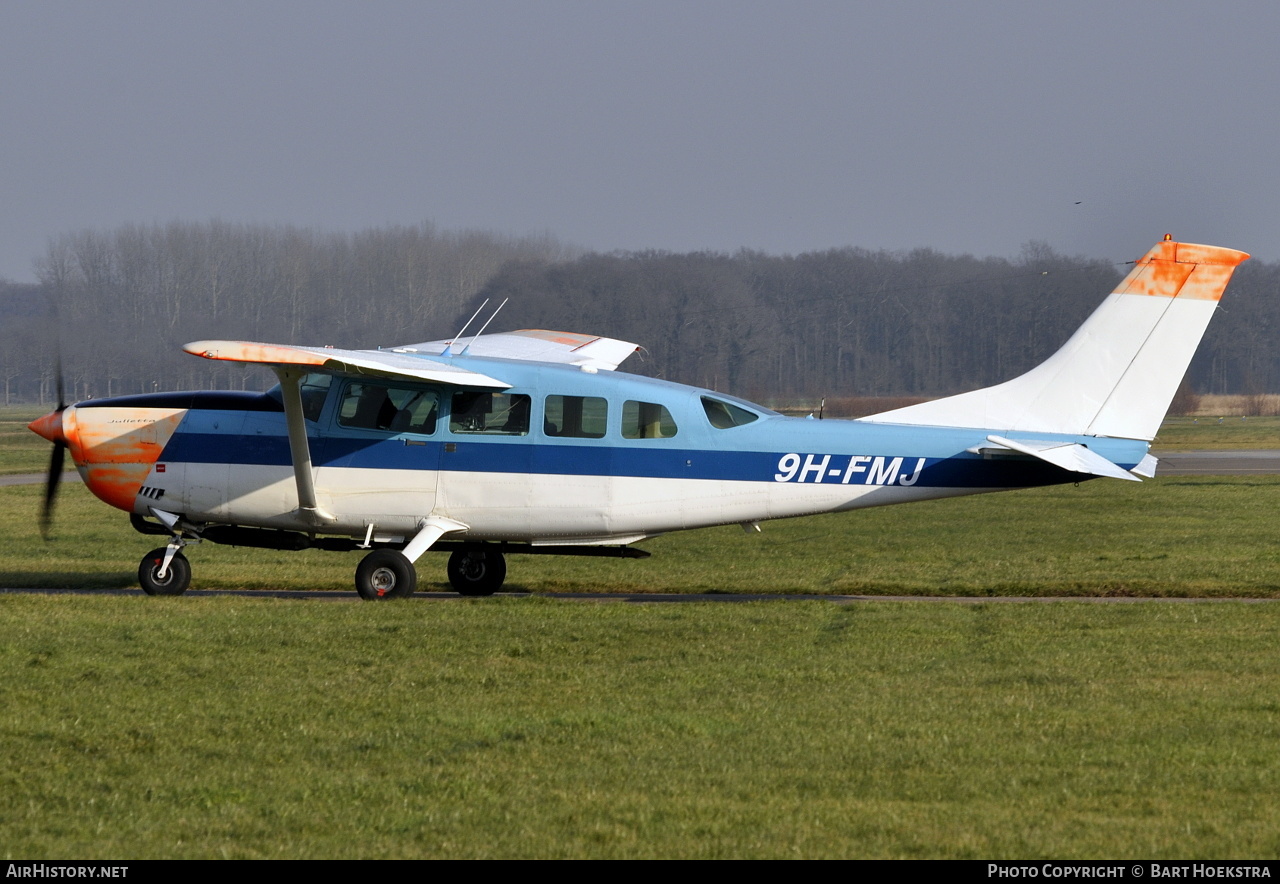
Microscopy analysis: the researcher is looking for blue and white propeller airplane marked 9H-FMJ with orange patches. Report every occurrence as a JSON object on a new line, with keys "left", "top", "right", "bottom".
{"left": 29, "top": 235, "right": 1249, "bottom": 600}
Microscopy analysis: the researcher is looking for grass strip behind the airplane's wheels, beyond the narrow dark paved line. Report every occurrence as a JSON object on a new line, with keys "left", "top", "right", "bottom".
{"left": 0, "top": 476, "right": 1280, "bottom": 597}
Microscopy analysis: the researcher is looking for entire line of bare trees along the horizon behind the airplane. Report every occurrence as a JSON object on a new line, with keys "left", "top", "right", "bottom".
{"left": 0, "top": 223, "right": 1280, "bottom": 402}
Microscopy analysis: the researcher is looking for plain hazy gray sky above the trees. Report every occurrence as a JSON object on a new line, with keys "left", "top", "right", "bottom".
{"left": 0, "top": 0, "right": 1280, "bottom": 280}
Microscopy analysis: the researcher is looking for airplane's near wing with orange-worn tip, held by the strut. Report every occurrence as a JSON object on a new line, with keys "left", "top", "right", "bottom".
{"left": 183, "top": 340, "right": 511, "bottom": 390}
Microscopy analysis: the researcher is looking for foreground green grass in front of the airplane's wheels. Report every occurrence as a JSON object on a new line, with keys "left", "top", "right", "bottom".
{"left": 0, "top": 596, "right": 1280, "bottom": 860}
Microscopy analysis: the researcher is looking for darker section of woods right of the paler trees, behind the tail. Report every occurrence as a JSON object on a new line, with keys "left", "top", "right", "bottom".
{"left": 477, "top": 243, "right": 1280, "bottom": 400}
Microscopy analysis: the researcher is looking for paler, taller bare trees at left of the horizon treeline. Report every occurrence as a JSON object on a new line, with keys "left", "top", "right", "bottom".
{"left": 0, "top": 221, "right": 575, "bottom": 402}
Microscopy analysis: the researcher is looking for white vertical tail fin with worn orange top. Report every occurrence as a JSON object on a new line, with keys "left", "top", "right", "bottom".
{"left": 861, "top": 238, "right": 1249, "bottom": 441}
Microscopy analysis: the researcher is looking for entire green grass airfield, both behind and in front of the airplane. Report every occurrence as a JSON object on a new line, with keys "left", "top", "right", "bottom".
{"left": 0, "top": 406, "right": 1280, "bottom": 860}
